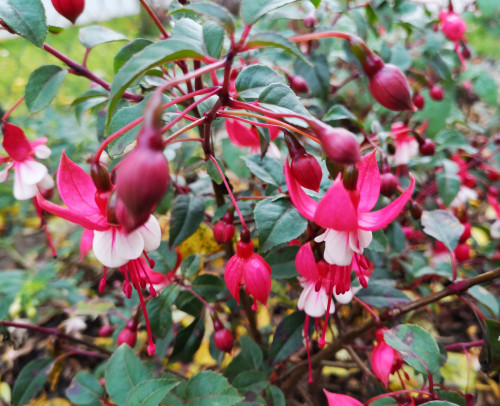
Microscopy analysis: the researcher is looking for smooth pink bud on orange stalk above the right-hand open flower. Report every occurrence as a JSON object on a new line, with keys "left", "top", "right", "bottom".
{"left": 309, "top": 120, "right": 361, "bottom": 164}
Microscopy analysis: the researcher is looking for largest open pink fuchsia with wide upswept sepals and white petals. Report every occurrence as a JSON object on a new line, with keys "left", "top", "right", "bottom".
{"left": 285, "top": 151, "right": 415, "bottom": 272}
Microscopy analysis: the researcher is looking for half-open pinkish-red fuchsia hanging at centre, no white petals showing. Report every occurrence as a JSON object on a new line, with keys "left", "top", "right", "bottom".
{"left": 224, "top": 238, "right": 271, "bottom": 310}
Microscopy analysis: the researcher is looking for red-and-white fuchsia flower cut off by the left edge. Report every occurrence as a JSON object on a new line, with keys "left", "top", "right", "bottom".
{"left": 0, "top": 122, "right": 54, "bottom": 200}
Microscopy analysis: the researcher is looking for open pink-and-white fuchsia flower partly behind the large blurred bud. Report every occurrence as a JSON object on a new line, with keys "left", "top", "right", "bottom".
{"left": 37, "top": 152, "right": 161, "bottom": 354}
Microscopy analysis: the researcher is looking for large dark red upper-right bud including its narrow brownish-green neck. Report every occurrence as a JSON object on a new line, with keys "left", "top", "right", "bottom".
{"left": 349, "top": 37, "right": 416, "bottom": 111}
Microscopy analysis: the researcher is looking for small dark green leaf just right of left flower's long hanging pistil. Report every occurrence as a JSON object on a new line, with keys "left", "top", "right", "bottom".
{"left": 147, "top": 284, "right": 180, "bottom": 338}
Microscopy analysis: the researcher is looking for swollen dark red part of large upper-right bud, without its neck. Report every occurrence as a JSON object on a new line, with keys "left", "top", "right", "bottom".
{"left": 368, "top": 64, "right": 416, "bottom": 111}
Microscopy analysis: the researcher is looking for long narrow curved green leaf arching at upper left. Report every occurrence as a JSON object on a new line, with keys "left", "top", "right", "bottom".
{"left": 108, "top": 38, "right": 203, "bottom": 125}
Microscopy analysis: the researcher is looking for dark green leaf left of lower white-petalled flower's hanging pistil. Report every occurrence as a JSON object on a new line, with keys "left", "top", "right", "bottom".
{"left": 269, "top": 311, "right": 313, "bottom": 365}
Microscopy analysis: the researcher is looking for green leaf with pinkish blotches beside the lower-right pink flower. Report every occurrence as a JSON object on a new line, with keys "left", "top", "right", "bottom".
{"left": 384, "top": 324, "right": 440, "bottom": 379}
